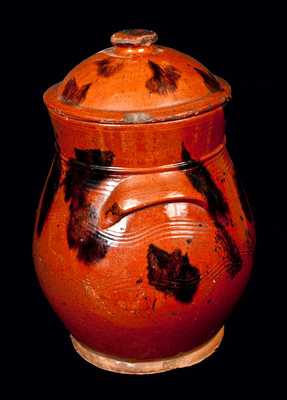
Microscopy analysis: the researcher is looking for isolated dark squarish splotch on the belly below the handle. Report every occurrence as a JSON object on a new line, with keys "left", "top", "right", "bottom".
{"left": 147, "top": 244, "right": 200, "bottom": 302}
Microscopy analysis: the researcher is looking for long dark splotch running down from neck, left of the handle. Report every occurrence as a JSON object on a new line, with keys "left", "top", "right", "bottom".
{"left": 64, "top": 149, "right": 114, "bottom": 264}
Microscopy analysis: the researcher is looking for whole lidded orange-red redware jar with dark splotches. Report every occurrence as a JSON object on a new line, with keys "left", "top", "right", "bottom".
{"left": 33, "top": 29, "right": 255, "bottom": 374}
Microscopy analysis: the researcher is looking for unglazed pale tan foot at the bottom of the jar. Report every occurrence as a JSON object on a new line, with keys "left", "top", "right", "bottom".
{"left": 71, "top": 326, "right": 224, "bottom": 375}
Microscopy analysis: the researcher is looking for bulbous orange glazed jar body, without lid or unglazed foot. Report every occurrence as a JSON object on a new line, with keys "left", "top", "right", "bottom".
{"left": 33, "top": 109, "right": 255, "bottom": 361}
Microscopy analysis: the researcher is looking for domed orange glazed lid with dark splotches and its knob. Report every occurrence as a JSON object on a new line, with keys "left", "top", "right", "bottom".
{"left": 44, "top": 29, "right": 231, "bottom": 124}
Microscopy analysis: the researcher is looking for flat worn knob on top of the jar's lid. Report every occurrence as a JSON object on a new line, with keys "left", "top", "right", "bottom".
{"left": 111, "top": 29, "right": 157, "bottom": 46}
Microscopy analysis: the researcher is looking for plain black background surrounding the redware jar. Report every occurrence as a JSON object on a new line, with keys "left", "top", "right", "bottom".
{"left": 8, "top": 2, "right": 287, "bottom": 398}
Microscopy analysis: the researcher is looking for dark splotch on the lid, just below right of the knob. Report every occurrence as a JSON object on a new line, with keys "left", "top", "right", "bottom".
{"left": 146, "top": 60, "right": 180, "bottom": 95}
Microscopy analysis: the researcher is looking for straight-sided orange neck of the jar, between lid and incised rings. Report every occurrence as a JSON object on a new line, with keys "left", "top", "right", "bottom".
{"left": 51, "top": 108, "right": 225, "bottom": 169}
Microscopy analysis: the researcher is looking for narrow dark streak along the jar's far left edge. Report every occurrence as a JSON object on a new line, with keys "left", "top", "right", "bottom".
{"left": 37, "top": 153, "right": 61, "bottom": 236}
